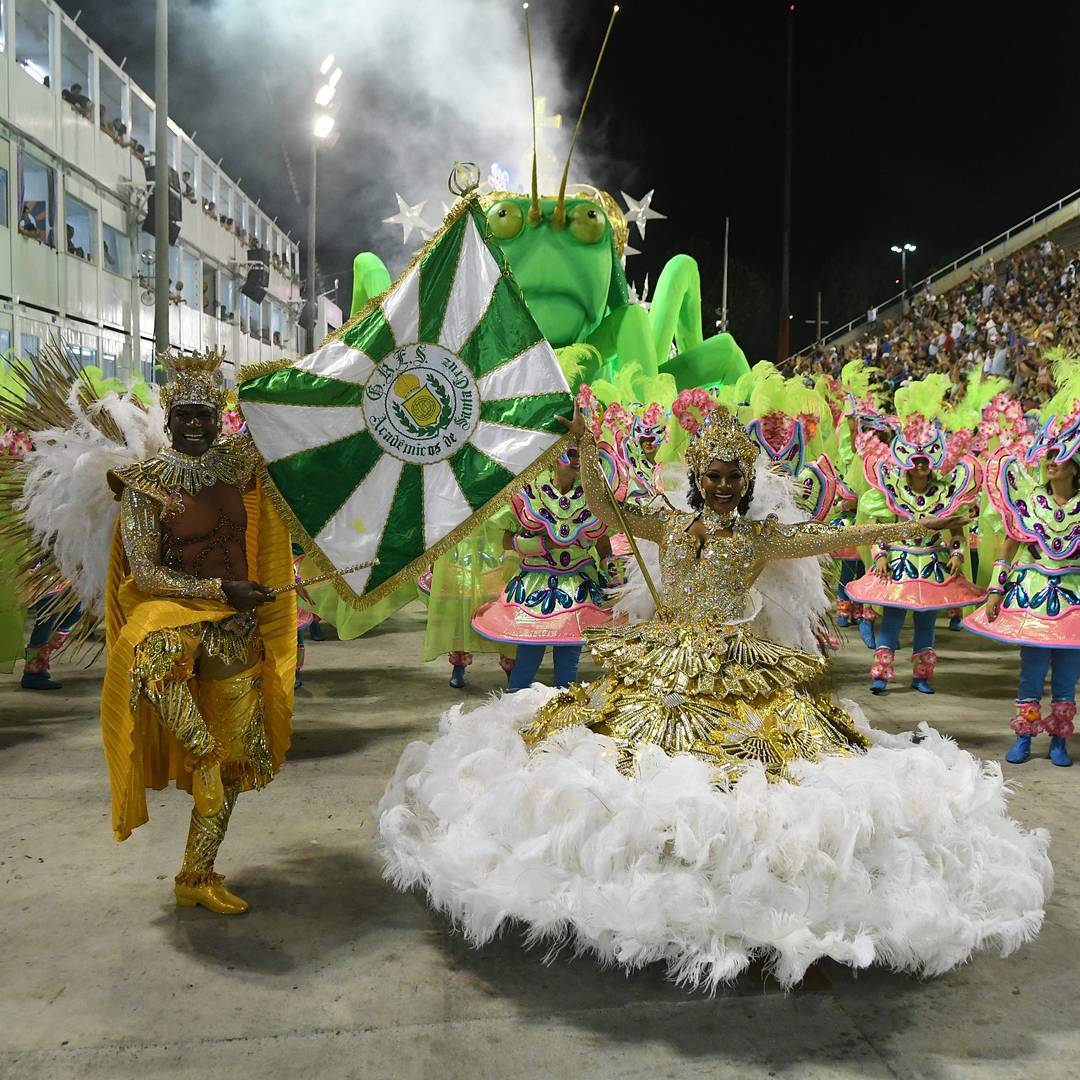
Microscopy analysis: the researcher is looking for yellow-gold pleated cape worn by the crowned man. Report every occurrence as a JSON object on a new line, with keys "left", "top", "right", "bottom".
{"left": 102, "top": 481, "right": 296, "bottom": 840}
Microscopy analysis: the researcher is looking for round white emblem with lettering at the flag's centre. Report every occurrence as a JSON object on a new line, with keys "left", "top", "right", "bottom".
{"left": 363, "top": 341, "right": 480, "bottom": 464}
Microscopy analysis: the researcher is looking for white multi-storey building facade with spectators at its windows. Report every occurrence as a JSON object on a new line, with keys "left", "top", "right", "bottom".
{"left": 0, "top": 0, "right": 303, "bottom": 381}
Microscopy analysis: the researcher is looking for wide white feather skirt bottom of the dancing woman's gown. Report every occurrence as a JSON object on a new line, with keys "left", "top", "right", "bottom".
{"left": 377, "top": 686, "right": 1052, "bottom": 991}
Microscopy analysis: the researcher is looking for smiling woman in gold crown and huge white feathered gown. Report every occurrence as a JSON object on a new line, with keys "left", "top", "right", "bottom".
{"left": 379, "top": 409, "right": 1052, "bottom": 989}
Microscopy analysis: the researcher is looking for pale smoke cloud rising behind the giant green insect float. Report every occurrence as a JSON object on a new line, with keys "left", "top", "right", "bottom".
{"left": 150, "top": 0, "right": 613, "bottom": 291}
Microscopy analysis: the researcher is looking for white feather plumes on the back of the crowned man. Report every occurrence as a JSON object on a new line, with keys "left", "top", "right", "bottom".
{"left": 15, "top": 384, "right": 165, "bottom": 616}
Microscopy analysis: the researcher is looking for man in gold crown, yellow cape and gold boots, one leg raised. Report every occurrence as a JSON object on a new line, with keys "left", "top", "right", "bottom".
{"left": 102, "top": 351, "right": 296, "bottom": 915}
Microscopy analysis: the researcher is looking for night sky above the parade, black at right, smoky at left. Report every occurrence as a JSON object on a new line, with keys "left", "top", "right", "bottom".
{"left": 63, "top": 0, "right": 1080, "bottom": 361}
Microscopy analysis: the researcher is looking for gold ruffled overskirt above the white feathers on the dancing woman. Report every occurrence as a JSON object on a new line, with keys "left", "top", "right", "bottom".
{"left": 522, "top": 616, "right": 868, "bottom": 781}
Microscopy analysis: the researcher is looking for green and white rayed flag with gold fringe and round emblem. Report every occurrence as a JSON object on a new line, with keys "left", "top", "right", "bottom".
{"left": 239, "top": 197, "right": 572, "bottom": 607}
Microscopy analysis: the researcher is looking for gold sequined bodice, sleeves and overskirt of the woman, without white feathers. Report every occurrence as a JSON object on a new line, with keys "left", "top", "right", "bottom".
{"left": 523, "top": 427, "right": 910, "bottom": 780}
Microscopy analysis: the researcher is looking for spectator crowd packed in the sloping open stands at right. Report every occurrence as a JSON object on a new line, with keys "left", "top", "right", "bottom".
{"left": 794, "top": 240, "right": 1080, "bottom": 408}
